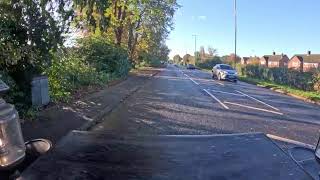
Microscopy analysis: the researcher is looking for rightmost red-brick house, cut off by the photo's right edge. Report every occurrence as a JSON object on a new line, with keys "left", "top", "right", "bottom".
{"left": 288, "top": 51, "right": 320, "bottom": 72}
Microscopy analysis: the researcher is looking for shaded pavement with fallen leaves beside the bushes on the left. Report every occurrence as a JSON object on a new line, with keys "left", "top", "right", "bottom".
{"left": 22, "top": 68, "right": 159, "bottom": 144}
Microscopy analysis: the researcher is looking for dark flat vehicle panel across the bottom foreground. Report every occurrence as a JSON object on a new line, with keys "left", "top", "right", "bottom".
{"left": 22, "top": 131, "right": 310, "bottom": 180}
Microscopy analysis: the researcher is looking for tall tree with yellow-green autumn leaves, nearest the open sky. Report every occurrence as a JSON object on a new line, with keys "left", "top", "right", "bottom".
{"left": 106, "top": 0, "right": 178, "bottom": 60}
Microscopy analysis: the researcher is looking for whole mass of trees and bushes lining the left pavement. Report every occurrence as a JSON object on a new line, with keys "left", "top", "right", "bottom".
{"left": 0, "top": 0, "right": 179, "bottom": 119}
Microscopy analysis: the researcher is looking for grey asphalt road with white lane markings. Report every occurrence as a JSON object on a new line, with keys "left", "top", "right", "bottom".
{"left": 91, "top": 65, "right": 320, "bottom": 145}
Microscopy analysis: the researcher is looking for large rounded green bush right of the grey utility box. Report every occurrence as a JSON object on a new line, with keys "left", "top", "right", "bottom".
{"left": 46, "top": 36, "right": 131, "bottom": 101}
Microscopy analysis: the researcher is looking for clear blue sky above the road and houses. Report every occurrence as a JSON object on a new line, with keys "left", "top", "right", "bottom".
{"left": 167, "top": 0, "right": 320, "bottom": 57}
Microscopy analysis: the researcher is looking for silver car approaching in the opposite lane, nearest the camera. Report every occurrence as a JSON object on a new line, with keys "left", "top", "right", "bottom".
{"left": 212, "top": 64, "right": 238, "bottom": 82}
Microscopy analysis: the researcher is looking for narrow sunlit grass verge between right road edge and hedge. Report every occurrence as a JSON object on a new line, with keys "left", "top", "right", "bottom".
{"left": 239, "top": 76, "right": 320, "bottom": 103}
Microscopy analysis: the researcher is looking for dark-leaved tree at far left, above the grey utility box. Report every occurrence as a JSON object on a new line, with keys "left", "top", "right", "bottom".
{"left": 0, "top": 0, "right": 73, "bottom": 104}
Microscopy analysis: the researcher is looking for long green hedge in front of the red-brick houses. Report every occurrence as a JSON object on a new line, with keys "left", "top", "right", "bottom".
{"left": 237, "top": 65, "right": 320, "bottom": 91}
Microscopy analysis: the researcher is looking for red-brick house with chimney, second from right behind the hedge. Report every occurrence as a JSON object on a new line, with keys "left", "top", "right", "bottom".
{"left": 260, "top": 52, "right": 290, "bottom": 68}
